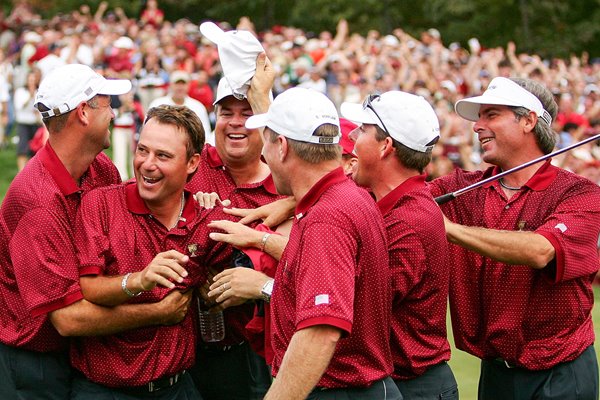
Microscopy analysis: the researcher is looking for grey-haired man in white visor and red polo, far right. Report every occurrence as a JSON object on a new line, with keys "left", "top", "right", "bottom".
{"left": 432, "top": 77, "right": 600, "bottom": 400}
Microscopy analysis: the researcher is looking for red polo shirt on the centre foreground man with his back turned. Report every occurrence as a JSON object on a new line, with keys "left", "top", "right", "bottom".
{"left": 271, "top": 168, "right": 392, "bottom": 388}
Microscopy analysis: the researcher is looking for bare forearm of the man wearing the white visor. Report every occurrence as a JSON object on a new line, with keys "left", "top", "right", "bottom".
{"left": 446, "top": 221, "right": 555, "bottom": 269}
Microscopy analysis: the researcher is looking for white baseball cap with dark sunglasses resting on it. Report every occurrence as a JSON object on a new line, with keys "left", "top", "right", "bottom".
{"left": 341, "top": 90, "right": 440, "bottom": 153}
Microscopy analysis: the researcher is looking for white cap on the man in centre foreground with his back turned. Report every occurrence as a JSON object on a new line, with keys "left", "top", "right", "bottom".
{"left": 246, "top": 87, "right": 340, "bottom": 144}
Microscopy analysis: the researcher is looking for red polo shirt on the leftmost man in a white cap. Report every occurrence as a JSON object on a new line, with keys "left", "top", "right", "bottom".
{"left": 0, "top": 143, "right": 120, "bottom": 352}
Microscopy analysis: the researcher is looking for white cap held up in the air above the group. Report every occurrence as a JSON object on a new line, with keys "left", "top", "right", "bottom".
{"left": 200, "top": 22, "right": 265, "bottom": 99}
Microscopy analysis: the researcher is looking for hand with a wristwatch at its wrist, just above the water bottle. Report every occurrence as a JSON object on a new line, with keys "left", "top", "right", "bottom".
{"left": 208, "top": 267, "right": 271, "bottom": 309}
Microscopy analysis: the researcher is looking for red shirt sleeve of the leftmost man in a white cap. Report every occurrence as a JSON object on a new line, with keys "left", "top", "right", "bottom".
{"left": 9, "top": 208, "right": 83, "bottom": 317}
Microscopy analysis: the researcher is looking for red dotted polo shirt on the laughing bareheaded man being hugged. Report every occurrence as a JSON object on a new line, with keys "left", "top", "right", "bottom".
{"left": 71, "top": 182, "right": 231, "bottom": 387}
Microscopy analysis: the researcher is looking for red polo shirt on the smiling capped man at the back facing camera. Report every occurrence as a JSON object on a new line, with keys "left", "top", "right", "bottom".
{"left": 186, "top": 144, "right": 283, "bottom": 346}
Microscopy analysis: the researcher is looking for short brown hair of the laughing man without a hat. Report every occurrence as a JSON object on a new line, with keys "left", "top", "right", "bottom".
{"left": 144, "top": 105, "right": 204, "bottom": 160}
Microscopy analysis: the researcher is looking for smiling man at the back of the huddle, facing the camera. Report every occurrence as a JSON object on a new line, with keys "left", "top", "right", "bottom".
{"left": 187, "top": 56, "right": 281, "bottom": 400}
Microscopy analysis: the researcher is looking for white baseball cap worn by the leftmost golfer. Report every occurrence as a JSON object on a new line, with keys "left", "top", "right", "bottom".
{"left": 34, "top": 64, "right": 131, "bottom": 118}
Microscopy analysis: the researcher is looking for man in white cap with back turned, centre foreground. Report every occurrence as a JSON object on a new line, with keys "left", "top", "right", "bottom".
{"left": 246, "top": 88, "right": 401, "bottom": 399}
